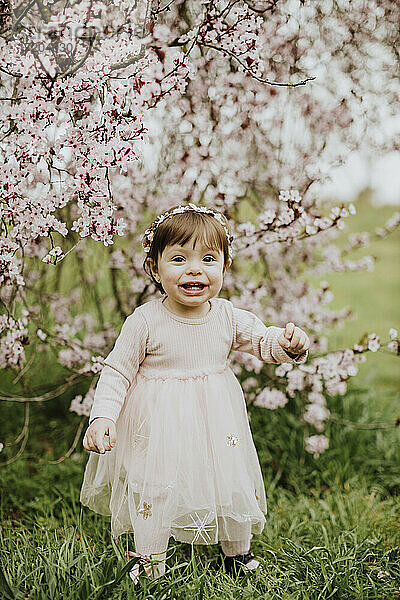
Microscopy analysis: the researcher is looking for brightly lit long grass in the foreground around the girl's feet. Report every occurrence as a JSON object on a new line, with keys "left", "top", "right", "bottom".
{"left": 0, "top": 460, "right": 400, "bottom": 600}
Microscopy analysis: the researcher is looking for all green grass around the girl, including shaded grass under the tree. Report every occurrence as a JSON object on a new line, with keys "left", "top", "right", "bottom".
{"left": 0, "top": 380, "right": 400, "bottom": 600}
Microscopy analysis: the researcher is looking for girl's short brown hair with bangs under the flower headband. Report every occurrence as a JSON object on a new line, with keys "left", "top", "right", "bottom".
{"left": 143, "top": 206, "right": 229, "bottom": 294}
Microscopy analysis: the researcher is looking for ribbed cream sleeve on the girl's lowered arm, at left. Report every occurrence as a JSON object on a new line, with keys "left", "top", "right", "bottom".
{"left": 89, "top": 311, "right": 148, "bottom": 423}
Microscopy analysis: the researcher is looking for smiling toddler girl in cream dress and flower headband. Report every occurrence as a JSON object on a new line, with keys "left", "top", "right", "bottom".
{"left": 80, "top": 204, "right": 310, "bottom": 582}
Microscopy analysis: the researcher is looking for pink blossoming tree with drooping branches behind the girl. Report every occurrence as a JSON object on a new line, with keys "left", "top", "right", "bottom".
{"left": 0, "top": 0, "right": 400, "bottom": 464}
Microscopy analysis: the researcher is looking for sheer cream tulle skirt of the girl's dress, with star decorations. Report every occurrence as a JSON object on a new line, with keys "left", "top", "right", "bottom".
{"left": 80, "top": 367, "right": 267, "bottom": 544}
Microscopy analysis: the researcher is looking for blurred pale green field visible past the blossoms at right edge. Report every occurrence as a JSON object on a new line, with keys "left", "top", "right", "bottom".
{"left": 307, "top": 197, "right": 400, "bottom": 416}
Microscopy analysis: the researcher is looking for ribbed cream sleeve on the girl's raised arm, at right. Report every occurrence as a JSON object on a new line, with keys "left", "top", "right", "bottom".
{"left": 232, "top": 307, "right": 308, "bottom": 364}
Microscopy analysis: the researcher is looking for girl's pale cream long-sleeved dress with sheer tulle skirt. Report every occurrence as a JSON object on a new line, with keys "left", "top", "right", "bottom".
{"left": 80, "top": 297, "right": 307, "bottom": 544}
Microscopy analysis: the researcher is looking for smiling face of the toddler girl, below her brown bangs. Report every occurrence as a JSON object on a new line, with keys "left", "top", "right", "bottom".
{"left": 152, "top": 240, "right": 231, "bottom": 318}
